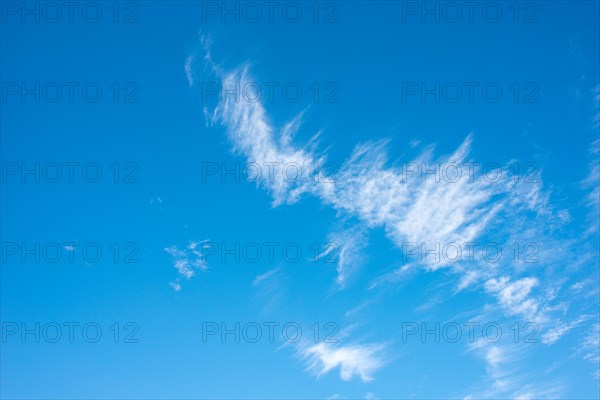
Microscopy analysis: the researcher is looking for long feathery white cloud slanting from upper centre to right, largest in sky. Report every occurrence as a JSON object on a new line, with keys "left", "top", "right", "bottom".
{"left": 211, "top": 67, "right": 516, "bottom": 276}
